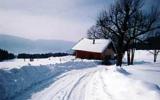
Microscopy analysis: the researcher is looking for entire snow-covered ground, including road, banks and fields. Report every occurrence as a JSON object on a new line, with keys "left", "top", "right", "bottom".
{"left": 0, "top": 51, "right": 160, "bottom": 100}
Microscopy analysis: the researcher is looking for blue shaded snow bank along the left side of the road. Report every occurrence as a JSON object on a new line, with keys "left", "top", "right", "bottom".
{"left": 0, "top": 60, "right": 96, "bottom": 100}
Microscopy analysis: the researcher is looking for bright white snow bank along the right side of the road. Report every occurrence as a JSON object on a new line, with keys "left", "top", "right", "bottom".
{"left": 84, "top": 67, "right": 160, "bottom": 100}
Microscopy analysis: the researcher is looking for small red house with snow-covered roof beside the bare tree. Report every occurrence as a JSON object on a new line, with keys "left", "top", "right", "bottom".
{"left": 72, "top": 38, "right": 115, "bottom": 60}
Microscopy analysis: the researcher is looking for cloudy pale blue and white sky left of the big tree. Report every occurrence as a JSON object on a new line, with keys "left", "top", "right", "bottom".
{"left": 0, "top": 0, "right": 159, "bottom": 41}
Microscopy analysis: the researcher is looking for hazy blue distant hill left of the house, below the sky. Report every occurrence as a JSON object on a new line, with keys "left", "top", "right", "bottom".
{"left": 0, "top": 34, "right": 75, "bottom": 54}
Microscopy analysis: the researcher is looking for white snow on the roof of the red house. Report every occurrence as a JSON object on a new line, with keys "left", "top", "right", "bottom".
{"left": 72, "top": 38, "right": 111, "bottom": 53}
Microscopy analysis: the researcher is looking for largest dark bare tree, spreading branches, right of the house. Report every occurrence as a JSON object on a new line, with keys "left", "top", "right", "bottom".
{"left": 96, "top": 0, "right": 160, "bottom": 66}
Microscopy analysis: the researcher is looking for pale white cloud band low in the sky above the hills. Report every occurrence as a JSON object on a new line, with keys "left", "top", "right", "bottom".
{"left": 0, "top": 10, "right": 90, "bottom": 41}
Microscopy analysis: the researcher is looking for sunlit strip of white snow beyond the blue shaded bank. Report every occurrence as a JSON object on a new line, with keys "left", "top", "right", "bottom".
{"left": 0, "top": 56, "right": 75, "bottom": 70}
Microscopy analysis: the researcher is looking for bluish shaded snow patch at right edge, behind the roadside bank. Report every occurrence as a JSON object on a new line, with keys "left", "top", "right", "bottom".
{"left": 124, "top": 63, "right": 160, "bottom": 87}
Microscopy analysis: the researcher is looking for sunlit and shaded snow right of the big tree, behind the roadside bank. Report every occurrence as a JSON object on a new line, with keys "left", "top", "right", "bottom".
{"left": 124, "top": 50, "right": 160, "bottom": 87}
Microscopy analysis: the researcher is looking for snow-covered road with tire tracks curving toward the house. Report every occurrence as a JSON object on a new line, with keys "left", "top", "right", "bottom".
{"left": 31, "top": 68, "right": 97, "bottom": 100}
